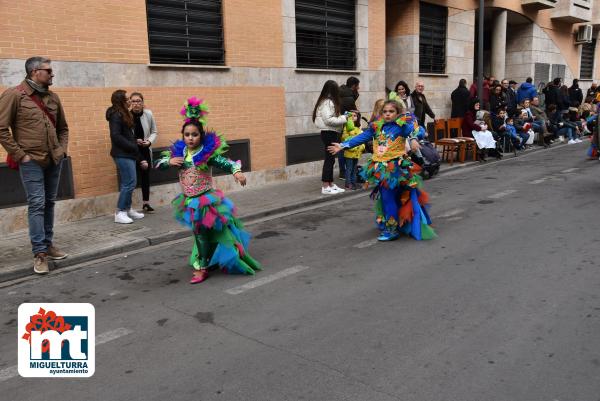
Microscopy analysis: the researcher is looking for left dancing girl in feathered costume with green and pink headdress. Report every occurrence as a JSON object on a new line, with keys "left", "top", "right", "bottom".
{"left": 156, "top": 97, "right": 261, "bottom": 284}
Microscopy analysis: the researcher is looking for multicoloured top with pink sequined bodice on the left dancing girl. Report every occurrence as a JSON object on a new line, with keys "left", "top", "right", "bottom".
{"left": 156, "top": 131, "right": 242, "bottom": 197}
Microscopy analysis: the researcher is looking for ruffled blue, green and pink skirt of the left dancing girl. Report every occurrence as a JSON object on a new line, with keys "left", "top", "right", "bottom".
{"left": 171, "top": 189, "right": 261, "bottom": 274}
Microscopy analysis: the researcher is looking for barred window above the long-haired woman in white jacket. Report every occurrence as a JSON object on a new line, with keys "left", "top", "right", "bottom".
{"left": 296, "top": 0, "right": 356, "bottom": 70}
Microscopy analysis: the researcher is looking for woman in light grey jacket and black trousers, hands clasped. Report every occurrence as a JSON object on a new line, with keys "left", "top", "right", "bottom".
{"left": 129, "top": 92, "right": 158, "bottom": 213}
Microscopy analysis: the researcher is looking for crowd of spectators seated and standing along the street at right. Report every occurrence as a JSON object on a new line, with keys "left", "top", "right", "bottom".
{"left": 451, "top": 77, "right": 600, "bottom": 152}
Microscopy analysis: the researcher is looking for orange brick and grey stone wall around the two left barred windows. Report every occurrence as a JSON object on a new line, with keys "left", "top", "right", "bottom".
{"left": 0, "top": 0, "right": 386, "bottom": 233}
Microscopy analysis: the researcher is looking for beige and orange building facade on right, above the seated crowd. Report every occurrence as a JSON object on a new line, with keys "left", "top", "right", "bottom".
{"left": 385, "top": 0, "right": 600, "bottom": 117}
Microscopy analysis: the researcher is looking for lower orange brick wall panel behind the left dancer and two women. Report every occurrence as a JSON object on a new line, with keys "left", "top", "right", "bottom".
{"left": 0, "top": 87, "right": 285, "bottom": 198}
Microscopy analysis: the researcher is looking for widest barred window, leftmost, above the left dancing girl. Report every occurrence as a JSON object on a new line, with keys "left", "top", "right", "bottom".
{"left": 146, "top": 0, "right": 225, "bottom": 65}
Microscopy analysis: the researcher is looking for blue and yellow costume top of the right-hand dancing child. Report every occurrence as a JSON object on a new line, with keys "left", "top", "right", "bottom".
{"left": 340, "top": 113, "right": 423, "bottom": 189}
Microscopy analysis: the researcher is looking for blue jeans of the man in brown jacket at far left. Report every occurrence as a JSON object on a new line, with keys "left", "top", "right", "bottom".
{"left": 19, "top": 160, "right": 62, "bottom": 255}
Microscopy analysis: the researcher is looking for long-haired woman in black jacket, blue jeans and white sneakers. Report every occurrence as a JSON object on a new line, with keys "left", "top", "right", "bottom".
{"left": 106, "top": 89, "right": 148, "bottom": 224}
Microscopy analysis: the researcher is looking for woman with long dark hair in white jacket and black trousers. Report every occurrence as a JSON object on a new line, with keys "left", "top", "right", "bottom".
{"left": 312, "top": 80, "right": 347, "bottom": 195}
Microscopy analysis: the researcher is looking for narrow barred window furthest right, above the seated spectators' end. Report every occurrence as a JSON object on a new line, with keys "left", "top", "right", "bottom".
{"left": 419, "top": 2, "right": 448, "bottom": 74}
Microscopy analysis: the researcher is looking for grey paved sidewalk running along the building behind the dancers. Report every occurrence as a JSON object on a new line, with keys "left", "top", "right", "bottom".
{"left": 0, "top": 145, "right": 548, "bottom": 283}
